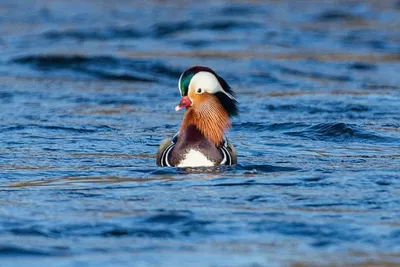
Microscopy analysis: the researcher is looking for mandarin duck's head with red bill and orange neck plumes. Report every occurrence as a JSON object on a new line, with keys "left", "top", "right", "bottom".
{"left": 175, "top": 66, "right": 238, "bottom": 146}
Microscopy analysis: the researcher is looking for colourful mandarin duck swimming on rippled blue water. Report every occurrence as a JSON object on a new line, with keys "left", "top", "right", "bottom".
{"left": 156, "top": 66, "right": 238, "bottom": 168}
